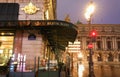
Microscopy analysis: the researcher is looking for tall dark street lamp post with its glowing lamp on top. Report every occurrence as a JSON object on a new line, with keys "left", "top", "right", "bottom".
{"left": 85, "top": 1, "right": 95, "bottom": 77}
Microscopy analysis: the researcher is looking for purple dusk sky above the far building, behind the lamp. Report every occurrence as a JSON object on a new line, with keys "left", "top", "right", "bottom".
{"left": 57, "top": 0, "right": 120, "bottom": 24}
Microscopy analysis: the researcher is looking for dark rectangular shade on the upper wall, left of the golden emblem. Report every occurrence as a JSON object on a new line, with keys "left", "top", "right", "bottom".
{"left": 0, "top": 3, "right": 19, "bottom": 20}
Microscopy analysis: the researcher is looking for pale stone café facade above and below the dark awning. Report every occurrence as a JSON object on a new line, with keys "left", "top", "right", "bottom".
{"left": 0, "top": 0, "right": 56, "bottom": 68}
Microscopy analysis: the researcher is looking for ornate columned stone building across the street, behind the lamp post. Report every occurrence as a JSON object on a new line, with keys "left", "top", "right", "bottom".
{"left": 77, "top": 24, "right": 120, "bottom": 77}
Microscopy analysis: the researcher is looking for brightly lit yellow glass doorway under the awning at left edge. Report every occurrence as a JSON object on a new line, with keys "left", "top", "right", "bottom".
{"left": 0, "top": 36, "right": 14, "bottom": 66}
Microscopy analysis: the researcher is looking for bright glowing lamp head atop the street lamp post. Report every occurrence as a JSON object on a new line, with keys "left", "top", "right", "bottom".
{"left": 85, "top": 2, "right": 95, "bottom": 20}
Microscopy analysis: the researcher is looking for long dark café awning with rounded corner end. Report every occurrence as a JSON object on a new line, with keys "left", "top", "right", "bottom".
{"left": 0, "top": 20, "right": 77, "bottom": 50}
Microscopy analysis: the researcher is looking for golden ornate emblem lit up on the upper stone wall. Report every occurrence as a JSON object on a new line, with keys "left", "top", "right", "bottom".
{"left": 22, "top": 2, "right": 39, "bottom": 14}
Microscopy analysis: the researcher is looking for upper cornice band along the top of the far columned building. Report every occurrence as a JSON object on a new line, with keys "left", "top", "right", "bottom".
{"left": 77, "top": 24, "right": 120, "bottom": 36}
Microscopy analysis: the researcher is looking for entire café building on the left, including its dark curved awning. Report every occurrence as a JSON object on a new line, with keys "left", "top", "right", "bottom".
{"left": 0, "top": 0, "right": 77, "bottom": 71}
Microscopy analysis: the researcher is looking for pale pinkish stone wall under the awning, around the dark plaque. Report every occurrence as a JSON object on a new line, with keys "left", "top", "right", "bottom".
{"left": 22, "top": 31, "right": 45, "bottom": 68}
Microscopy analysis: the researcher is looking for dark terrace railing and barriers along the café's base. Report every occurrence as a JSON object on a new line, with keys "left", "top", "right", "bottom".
{"left": 0, "top": 57, "right": 67, "bottom": 77}
